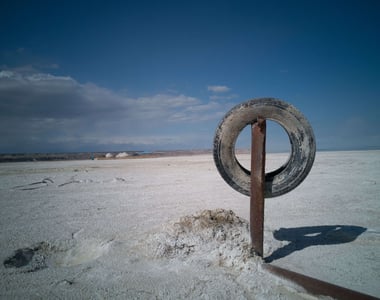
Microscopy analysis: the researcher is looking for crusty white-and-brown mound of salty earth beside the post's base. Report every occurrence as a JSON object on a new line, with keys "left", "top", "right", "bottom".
{"left": 147, "top": 209, "right": 253, "bottom": 269}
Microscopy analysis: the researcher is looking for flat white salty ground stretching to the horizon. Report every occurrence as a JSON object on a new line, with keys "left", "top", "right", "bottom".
{"left": 0, "top": 151, "right": 380, "bottom": 299}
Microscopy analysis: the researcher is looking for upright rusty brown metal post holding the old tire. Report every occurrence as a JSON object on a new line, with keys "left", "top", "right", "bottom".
{"left": 250, "top": 117, "right": 266, "bottom": 257}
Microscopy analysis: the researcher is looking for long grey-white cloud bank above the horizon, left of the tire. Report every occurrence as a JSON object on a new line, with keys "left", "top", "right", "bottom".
{"left": 0, "top": 70, "right": 230, "bottom": 152}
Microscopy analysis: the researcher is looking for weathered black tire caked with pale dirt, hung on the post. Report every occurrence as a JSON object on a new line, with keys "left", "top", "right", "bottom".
{"left": 214, "top": 98, "right": 316, "bottom": 198}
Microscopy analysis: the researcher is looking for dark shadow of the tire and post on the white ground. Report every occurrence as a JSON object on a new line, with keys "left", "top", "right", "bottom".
{"left": 265, "top": 225, "right": 367, "bottom": 263}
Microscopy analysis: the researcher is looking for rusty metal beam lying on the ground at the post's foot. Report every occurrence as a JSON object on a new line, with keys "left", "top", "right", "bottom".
{"left": 263, "top": 264, "right": 379, "bottom": 300}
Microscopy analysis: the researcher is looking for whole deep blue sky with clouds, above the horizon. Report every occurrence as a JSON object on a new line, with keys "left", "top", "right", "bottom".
{"left": 0, "top": 0, "right": 380, "bottom": 153}
